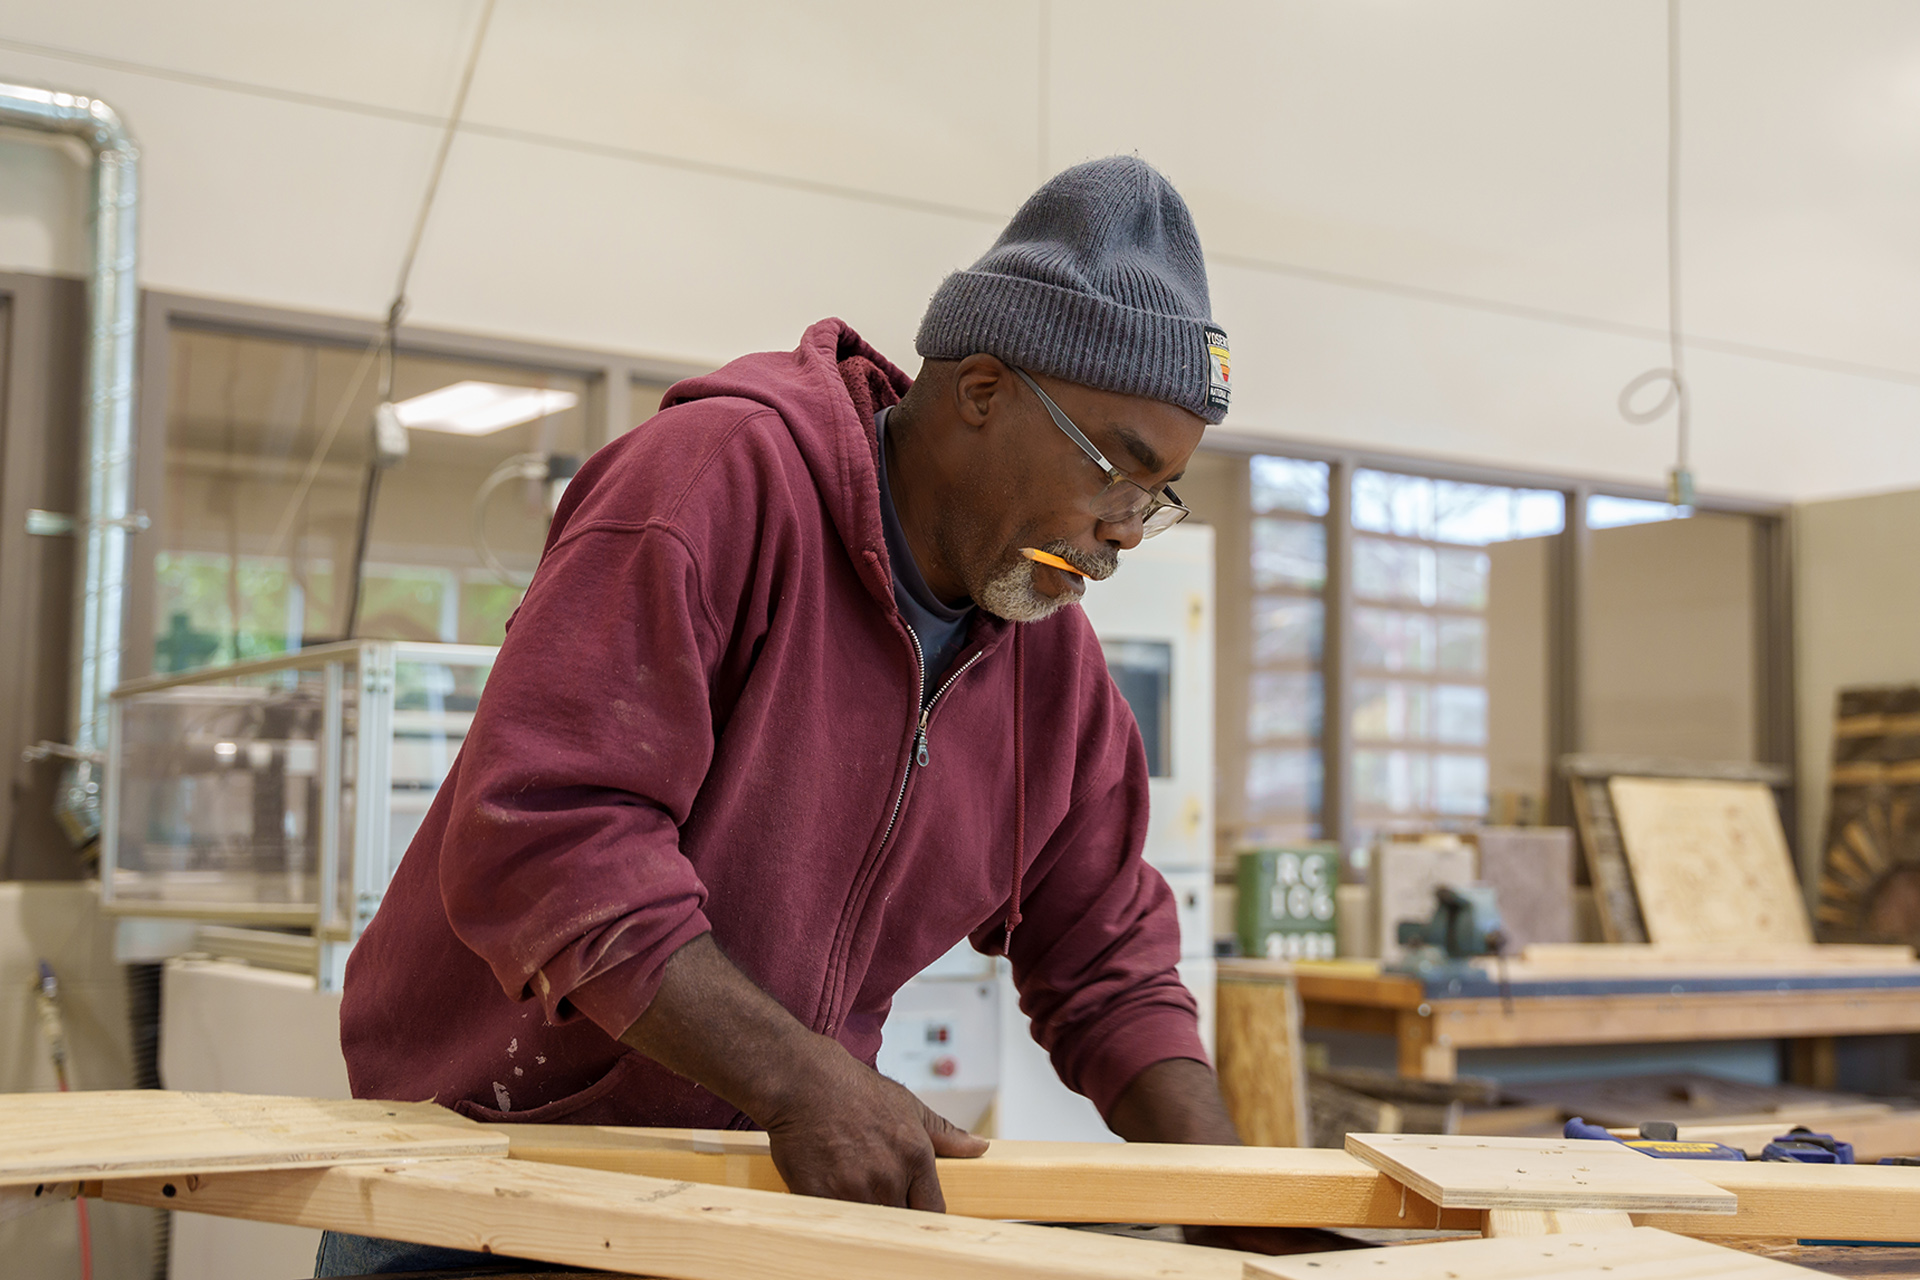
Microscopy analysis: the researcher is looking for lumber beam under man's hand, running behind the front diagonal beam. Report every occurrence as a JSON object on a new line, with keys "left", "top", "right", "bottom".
{"left": 493, "top": 1125, "right": 1480, "bottom": 1230}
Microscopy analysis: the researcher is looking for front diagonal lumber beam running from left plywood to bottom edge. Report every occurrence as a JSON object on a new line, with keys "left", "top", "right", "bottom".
{"left": 104, "top": 1159, "right": 1250, "bottom": 1280}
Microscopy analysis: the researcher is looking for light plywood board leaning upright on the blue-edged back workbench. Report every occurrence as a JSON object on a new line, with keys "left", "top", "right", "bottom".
{"left": 1607, "top": 777, "right": 1812, "bottom": 946}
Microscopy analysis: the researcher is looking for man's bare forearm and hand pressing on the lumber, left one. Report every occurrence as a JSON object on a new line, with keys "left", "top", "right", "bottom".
{"left": 620, "top": 935, "right": 987, "bottom": 1213}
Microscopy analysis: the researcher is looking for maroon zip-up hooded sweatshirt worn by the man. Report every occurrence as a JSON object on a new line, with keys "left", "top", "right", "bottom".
{"left": 340, "top": 320, "right": 1206, "bottom": 1128}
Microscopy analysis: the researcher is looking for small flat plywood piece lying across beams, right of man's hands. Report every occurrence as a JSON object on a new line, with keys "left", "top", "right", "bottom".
{"left": 1346, "top": 1134, "right": 1738, "bottom": 1213}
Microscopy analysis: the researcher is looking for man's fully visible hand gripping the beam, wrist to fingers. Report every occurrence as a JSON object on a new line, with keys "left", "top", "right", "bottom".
{"left": 756, "top": 1036, "right": 987, "bottom": 1213}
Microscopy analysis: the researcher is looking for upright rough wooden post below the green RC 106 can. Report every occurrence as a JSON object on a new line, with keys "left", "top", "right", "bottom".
{"left": 1213, "top": 960, "right": 1313, "bottom": 1148}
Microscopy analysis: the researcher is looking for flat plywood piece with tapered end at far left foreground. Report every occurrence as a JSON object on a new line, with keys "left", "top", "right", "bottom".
{"left": 0, "top": 1090, "right": 507, "bottom": 1186}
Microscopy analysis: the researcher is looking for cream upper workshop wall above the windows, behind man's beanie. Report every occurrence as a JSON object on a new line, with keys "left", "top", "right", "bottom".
{"left": 0, "top": 0, "right": 1920, "bottom": 499}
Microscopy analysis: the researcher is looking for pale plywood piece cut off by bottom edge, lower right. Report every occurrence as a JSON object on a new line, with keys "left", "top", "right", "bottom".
{"left": 1244, "top": 1226, "right": 1809, "bottom": 1280}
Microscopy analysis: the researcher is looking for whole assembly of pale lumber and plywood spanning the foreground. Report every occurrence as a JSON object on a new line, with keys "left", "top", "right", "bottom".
{"left": 11, "top": 1092, "right": 1920, "bottom": 1280}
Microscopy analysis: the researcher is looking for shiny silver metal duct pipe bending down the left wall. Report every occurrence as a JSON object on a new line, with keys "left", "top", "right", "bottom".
{"left": 0, "top": 84, "right": 146, "bottom": 844}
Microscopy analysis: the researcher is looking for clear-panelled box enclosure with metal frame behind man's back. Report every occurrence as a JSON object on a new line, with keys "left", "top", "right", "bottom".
{"left": 100, "top": 641, "right": 497, "bottom": 984}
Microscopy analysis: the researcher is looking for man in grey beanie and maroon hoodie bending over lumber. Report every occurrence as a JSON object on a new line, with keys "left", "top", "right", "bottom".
{"left": 334, "top": 157, "right": 1320, "bottom": 1274}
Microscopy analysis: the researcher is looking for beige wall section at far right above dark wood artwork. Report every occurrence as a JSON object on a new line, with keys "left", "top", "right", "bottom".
{"left": 1793, "top": 489, "right": 1920, "bottom": 875}
